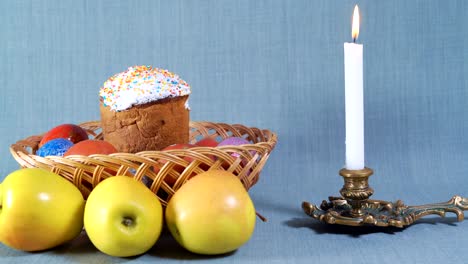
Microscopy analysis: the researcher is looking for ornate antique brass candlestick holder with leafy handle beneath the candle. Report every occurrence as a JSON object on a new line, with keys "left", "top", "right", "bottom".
{"left": 302, "top": 168, "right": 468, "bottom": 227}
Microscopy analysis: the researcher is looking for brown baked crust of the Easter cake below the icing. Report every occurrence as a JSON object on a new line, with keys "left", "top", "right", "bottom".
{"left": 100, "top": 95, "right": 190, "bottom": 153}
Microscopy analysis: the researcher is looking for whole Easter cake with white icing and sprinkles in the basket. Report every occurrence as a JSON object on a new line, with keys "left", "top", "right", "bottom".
{"left": 99, "top": 66, "right": 191, "bottom": 153}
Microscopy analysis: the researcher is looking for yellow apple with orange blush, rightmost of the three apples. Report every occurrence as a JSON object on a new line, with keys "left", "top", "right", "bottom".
{"left": 166, "top": 170, "right": 256, "bottom": 255}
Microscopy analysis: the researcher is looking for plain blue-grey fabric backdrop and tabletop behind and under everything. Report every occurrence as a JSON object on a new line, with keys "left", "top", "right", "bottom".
{"left": 0, "top": 0, "right": 468, "bottom": 263}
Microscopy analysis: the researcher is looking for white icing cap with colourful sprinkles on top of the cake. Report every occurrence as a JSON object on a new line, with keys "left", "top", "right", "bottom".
{"left": 99, "top": 66, "right": 191, "bottom": 111}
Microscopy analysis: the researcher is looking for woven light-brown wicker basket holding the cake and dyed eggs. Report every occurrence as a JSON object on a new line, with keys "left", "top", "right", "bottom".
{"left": 10, "top": 121, "right": 277, "bottom": 206}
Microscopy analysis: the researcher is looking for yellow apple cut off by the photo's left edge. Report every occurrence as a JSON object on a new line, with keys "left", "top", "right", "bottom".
{"left": 0, "top": 168, "right": 85, "bottom": 251}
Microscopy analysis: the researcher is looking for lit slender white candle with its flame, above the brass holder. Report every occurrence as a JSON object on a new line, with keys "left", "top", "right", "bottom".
{"left": 344, "top": 5, "right": 364, "bottom": 170}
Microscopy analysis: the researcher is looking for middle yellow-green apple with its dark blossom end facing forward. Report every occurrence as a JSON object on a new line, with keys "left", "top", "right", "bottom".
{"left": 84, "top": 176, "right": 163, "bottom": 257}
